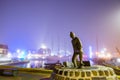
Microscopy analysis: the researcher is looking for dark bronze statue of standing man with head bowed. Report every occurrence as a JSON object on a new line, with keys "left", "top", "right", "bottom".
{"left": 70, "top": 32, "right": 83, "bottom": 68}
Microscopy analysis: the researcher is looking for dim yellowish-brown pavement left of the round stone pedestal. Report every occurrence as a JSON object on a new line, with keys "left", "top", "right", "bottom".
{"left": 0, "top": 72, "right": 50, "bottom": 80}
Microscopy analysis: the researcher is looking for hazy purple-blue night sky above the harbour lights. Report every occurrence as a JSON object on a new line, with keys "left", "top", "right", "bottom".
{"left": 0, "top": 0, "right": 120, "bottom": 53}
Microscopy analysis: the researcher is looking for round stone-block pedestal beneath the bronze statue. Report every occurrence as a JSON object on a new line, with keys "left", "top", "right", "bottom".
{"left": 50, "top": 65, "right": 117, "bottom": 80}
